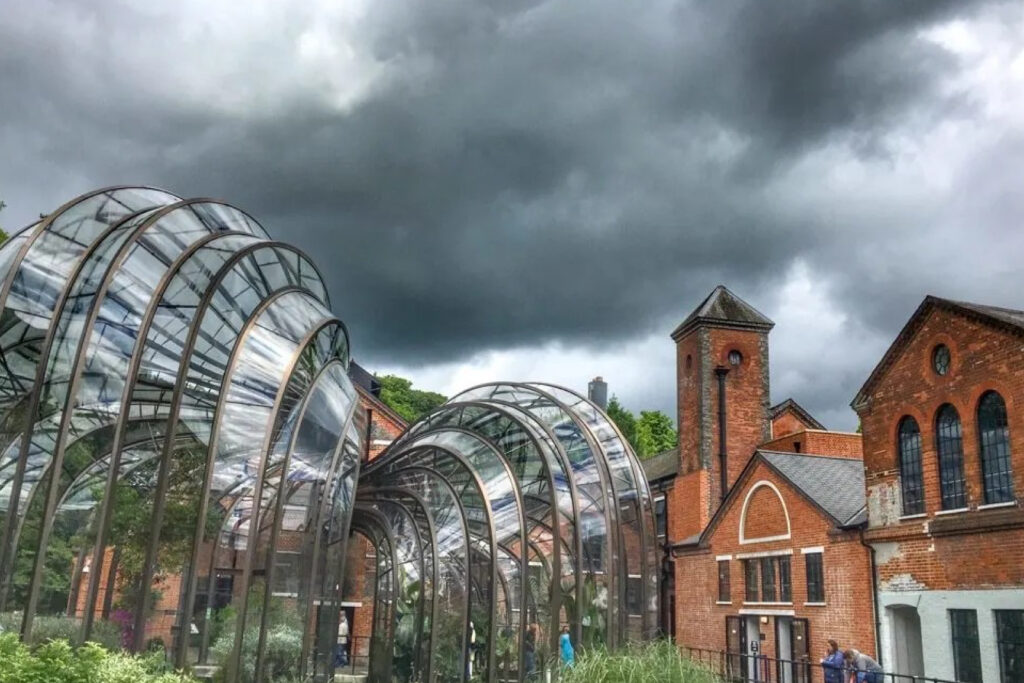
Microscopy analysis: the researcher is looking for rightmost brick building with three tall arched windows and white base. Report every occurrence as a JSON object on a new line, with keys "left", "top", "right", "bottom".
{"left": 853, "top": 297, "right": 1024, "bottom": 683}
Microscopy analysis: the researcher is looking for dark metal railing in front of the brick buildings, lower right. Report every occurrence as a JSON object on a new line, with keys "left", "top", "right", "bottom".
{"left": 681, "top": 646, "right": 957, "bottom": 683}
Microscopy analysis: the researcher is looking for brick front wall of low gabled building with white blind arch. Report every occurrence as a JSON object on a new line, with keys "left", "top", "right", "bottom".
{"left": 675, "top": 463, "right": 874, "bottom": 661}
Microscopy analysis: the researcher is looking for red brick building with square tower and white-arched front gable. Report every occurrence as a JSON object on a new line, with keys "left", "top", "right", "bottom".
{"left": 645, "top": 287, "right": 876, "bottom": 680}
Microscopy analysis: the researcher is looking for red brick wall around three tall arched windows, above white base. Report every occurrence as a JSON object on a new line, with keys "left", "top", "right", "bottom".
{"left": 858, "top": 306, "right": 1024, "bottom": 591}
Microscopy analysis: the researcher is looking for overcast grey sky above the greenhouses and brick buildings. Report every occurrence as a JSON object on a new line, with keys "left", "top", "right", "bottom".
{"left": 0, "top": 0, "right": 1024, "bottom": 429}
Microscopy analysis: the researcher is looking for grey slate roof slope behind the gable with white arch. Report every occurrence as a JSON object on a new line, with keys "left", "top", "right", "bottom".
{"left": 758, "top": 451, "right": 864, "bottom": 526}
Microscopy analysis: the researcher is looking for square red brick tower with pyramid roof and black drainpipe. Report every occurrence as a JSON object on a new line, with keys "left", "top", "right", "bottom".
{"left": 670, "top": 285, "right": 775, "bottom": 541}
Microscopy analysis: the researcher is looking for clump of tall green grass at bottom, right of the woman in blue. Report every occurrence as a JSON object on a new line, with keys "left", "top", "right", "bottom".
{"left": 560, "top": 640, "right": 719, "bottom": 683}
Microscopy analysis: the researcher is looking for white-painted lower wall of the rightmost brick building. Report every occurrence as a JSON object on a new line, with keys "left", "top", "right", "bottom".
{"left": 879, "top": 589, "right": 1024, "bottom": 683}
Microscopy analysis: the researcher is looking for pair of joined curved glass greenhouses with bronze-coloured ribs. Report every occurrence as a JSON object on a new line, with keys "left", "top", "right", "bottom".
{"left": 0, "top": 187, "right": 658, "bottom": 682}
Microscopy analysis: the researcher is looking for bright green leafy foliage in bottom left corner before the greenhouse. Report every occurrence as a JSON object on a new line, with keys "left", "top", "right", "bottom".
{"left": 0, "top": 633, "right": 196, "bottom": 683}
